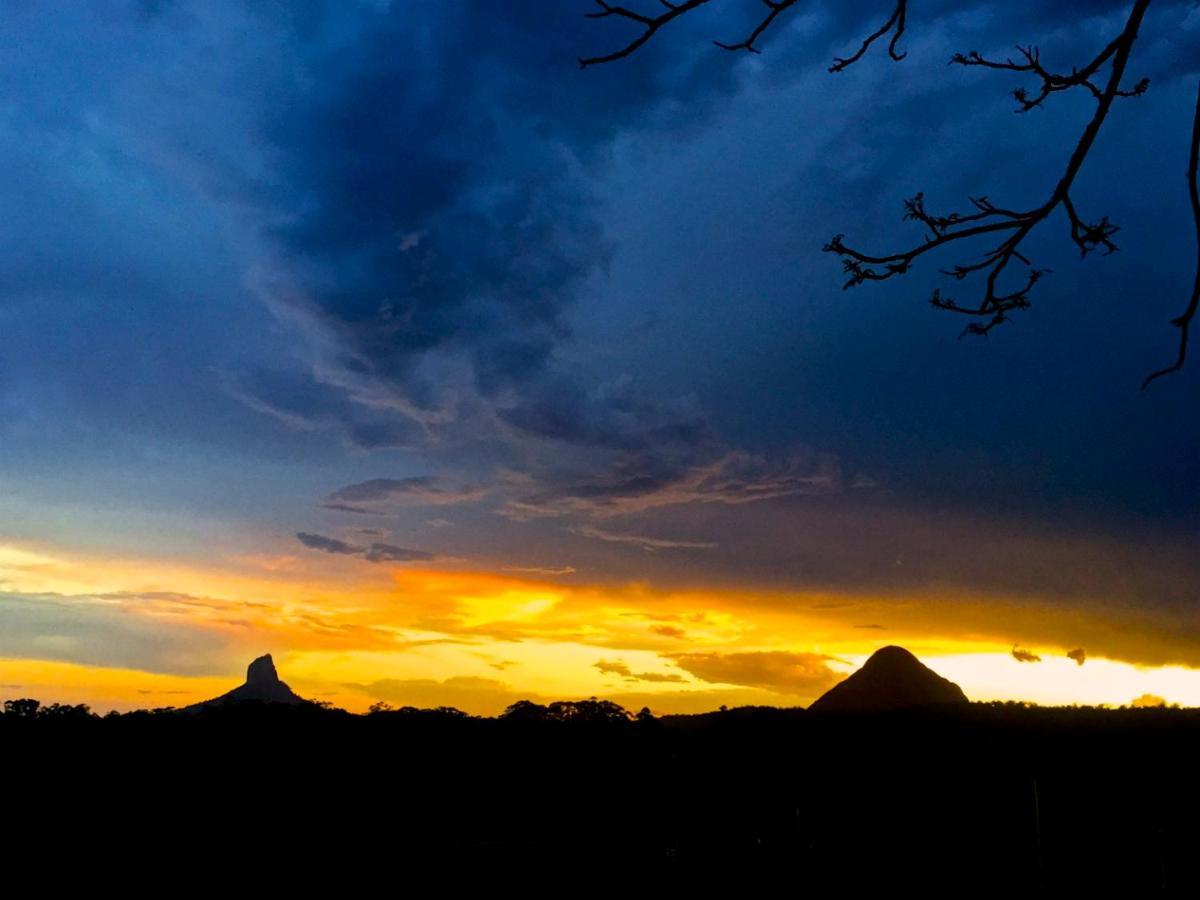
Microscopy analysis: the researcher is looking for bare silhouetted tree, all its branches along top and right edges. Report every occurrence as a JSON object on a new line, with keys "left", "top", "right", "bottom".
{"left": 580, "top": 0, "right": 1200, "bottom": 389}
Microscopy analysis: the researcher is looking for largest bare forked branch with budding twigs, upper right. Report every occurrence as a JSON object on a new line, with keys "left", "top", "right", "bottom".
{"left": 824, "top": 0, "right": 1151, "bottom": 335}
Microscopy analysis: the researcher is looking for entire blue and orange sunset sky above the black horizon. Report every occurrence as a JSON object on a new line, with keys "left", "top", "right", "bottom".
{"left": 0, "top": 0, "right": 1200, "bottom": 714}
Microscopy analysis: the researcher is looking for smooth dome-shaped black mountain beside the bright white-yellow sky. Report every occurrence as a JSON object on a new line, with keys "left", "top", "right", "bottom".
{"left": 809, "top": 647, "right": 967, "bottom": 713}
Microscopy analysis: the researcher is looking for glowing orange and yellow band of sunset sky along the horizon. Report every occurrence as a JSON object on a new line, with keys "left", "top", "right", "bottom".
{"left": 0, "top": 545, "right": 1200, "bottom": 713}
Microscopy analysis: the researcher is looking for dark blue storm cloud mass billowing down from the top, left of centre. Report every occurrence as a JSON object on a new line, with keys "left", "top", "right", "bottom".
{"left": 236, "top": 1, "right": 748, "bottom": 439}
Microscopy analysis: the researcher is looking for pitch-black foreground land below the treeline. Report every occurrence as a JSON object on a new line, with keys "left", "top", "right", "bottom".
{"left": 0, "top": 702, "right": 1200, "bottom": 896}
